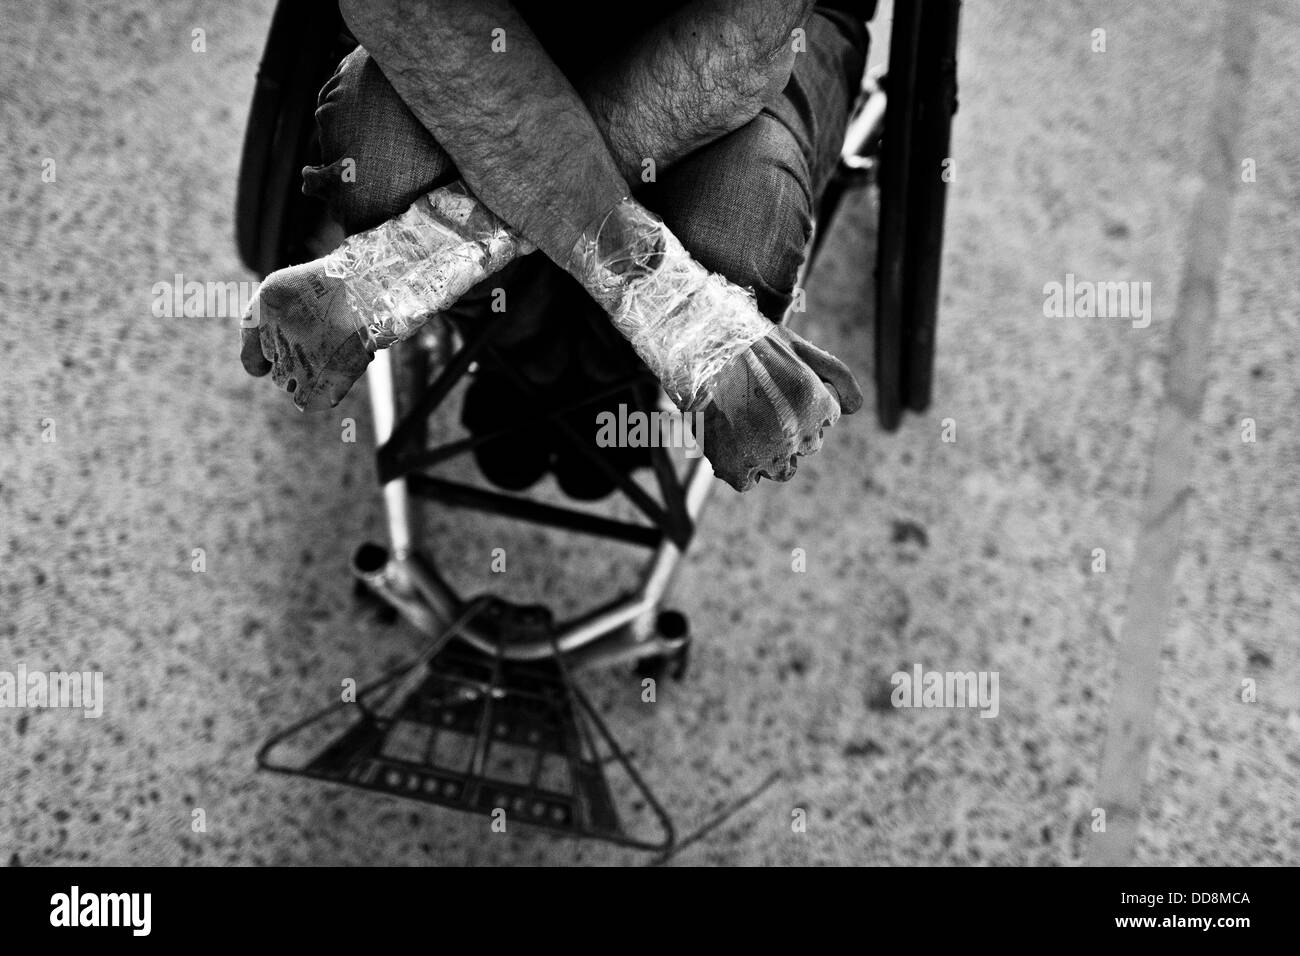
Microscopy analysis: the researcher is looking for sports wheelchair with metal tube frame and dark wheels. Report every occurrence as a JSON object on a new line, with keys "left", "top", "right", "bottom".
{"left": 235, "top": 0, "right": 961, "bottom": 853}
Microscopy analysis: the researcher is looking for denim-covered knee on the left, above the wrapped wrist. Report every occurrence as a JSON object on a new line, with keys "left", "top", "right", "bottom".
{"left": 303, "top": 47, "right": 454, "bottom": 233}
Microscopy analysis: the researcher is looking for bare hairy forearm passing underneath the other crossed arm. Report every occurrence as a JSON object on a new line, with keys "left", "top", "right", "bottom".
{"left": 581, "top": 0, "right": 815, "bottom": 182}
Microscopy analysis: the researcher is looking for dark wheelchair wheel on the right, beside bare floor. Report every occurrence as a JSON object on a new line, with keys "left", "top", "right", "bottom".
{"left": 875, "top": 0, "right": 961, "bottom": 431}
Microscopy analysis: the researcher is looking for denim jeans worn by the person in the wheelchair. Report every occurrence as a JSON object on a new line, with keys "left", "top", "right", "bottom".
{"left": 303, "top": 9, "right": 867, "bottom": 321}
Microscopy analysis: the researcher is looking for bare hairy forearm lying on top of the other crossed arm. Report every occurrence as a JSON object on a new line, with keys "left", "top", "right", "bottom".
{"left": 339, "top": 0, "right": 629, "bottom": 268}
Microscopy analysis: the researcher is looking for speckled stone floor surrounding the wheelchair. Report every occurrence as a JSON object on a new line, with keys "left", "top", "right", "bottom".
{"left": 0, "top": 0, "right": 1300, "bottom": 865}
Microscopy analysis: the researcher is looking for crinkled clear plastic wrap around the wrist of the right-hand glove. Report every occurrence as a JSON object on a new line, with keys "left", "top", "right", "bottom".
{"left": 571, "top": 198, "right": 776, "bottom": 411}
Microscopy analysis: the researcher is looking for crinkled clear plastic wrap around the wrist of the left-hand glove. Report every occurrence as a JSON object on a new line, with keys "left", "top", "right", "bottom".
{"left": 325, "top": 182, "right": 533, "bottom": 349}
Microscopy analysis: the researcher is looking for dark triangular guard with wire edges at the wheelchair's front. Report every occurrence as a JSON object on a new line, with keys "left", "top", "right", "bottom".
{"left": 257, "top": 597, "right": 675, "bottom": 852}
